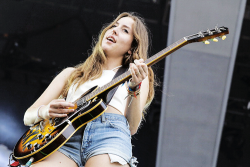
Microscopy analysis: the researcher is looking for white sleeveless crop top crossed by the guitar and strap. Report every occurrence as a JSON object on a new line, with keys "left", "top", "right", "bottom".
{"left": 66, "top": 70, "right": 128, "bottom": 115}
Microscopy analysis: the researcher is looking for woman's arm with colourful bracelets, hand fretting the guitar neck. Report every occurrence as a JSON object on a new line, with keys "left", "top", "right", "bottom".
{"left": 124, "top": 59, "right": 149, "bottom": 135}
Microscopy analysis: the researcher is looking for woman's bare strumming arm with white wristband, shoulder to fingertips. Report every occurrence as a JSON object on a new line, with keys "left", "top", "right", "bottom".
{"left": 23, "top": 68, "right": 75, "bottom": 126}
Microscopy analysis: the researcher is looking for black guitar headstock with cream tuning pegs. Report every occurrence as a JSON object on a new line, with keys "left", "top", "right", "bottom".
{"left": 184, "top": 26, "right": 229, "bottom": 44}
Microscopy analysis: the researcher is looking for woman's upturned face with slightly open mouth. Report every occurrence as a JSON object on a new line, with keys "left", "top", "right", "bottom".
{"left": 102, "top": 17, "right": 134, "bottom": 57}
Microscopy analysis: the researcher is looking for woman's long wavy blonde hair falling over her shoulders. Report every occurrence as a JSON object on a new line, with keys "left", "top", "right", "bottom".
{"left": 62, "top": 12, "right": 154, "bottom": 112}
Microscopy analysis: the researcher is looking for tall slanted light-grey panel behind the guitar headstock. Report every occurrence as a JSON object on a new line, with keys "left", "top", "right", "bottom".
{"left": 156, "top": 0, "right": 246, "bottom": 167}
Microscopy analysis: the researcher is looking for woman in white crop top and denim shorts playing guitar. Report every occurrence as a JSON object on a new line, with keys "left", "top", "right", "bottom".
{"left": 24, "top": 13, "right": 154, "bottom": 167}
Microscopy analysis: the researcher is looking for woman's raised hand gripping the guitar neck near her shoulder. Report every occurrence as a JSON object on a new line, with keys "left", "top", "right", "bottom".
{"left": 129, "top": 59, "right": 148, "bottom": 88}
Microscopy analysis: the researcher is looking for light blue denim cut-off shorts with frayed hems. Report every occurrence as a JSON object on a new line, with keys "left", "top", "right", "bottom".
{"left": 58, "top": 113, "right": 136, "bottom": 167}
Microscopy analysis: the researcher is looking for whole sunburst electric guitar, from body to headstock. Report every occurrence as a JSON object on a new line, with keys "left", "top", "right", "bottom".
{"left": 13, "top": 27, "right": 229, "bottom": 165}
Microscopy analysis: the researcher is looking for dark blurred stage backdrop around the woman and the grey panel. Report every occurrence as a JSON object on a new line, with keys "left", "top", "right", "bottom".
{"left": 0, "top": 0, "right": 250, "bottom": 167}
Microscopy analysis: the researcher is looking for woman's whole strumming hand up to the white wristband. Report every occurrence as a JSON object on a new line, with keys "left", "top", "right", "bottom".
{"left": 39, "top": 99, "right": 74, "bottom": 119}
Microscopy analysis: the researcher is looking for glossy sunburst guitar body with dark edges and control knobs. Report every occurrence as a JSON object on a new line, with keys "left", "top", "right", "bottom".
{"left": 13, "top": 88, "right": 107, "bottom": 165}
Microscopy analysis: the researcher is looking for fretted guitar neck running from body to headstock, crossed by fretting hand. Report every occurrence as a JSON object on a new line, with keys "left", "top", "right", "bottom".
{"left": 85, "top": 38, "right": 188, "bottom": 101}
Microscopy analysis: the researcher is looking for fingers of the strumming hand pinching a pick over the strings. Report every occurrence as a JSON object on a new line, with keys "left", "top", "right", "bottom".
{"left": 48, "top": 99, "right": 74, "bottom": 117}
